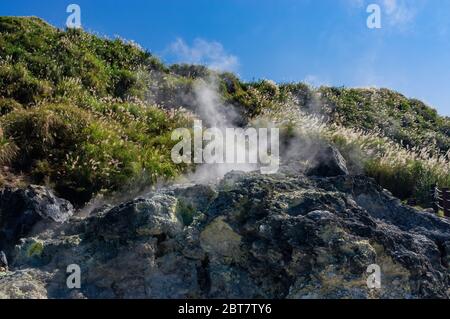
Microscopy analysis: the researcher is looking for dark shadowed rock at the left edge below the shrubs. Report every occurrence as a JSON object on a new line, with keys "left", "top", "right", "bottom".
{"left": 0, "top": 185, "right": 73, "bottom": 254}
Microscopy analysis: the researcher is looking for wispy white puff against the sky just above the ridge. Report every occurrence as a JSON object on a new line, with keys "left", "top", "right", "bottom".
{"left": 168, "top": 38, "right": 239, "bottom": 72}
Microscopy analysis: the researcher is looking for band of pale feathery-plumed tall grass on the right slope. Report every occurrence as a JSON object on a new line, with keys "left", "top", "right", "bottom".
{"left": 261, "top": 92, "right": 450, "bottom": 206}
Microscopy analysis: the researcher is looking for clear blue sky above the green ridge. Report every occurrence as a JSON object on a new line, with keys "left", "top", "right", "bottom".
{"left": 0, "top": 0, "right": 450, "bottom": 115}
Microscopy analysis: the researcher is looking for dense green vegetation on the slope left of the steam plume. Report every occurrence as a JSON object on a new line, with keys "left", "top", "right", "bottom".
{"left": 0, "top": 18, "right": 189, "bottom": 203}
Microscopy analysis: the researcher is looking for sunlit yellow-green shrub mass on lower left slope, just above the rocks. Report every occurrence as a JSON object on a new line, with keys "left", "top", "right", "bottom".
{"left": 1, "top": 104, "right": 192, "bottom": 203}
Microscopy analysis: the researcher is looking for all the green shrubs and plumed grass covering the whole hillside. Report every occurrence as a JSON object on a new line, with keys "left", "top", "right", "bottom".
{"left": 0, "top": 17, "right": 450, "bottom": 209}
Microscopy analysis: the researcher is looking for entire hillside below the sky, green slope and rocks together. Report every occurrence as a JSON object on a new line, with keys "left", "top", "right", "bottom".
{"left": 0, "top": 17, "right": 450, "bottom": 298}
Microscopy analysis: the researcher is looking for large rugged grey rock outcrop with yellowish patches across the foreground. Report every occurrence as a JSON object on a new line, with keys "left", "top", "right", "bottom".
{"left": 0, "top": 172, "right": 450, "bottom": 298}
